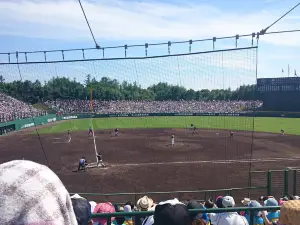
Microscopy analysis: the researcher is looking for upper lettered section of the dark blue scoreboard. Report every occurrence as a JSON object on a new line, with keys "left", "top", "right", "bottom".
{"left": 257, "top": 77, "right": 300, "bottom": 93}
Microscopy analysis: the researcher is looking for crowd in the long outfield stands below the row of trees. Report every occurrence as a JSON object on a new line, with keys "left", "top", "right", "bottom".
{"left": 45, "top": 100, "right": 262, "bottom": 114}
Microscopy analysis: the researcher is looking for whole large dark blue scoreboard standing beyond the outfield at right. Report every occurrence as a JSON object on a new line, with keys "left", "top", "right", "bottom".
{"left": 257, "top": 77, "right": 300, "bottom": 112}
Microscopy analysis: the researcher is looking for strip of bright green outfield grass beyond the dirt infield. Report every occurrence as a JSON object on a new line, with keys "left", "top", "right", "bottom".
{"left": 40, "top": 116, "right": 300, "bottom": 135}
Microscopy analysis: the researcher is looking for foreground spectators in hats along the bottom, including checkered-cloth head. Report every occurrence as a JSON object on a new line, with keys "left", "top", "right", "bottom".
{"left": 0, "top": 160, "right": 300, "bottom": 225}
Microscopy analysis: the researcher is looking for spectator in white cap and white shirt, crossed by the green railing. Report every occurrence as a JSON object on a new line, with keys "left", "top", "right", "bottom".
{"left": 209, "top": 196, "right": 249, "bottom": 225}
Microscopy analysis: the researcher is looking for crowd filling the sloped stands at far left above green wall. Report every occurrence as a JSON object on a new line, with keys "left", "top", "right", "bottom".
{"left": 0, "top": 93, "right": 47, "bottom": 123}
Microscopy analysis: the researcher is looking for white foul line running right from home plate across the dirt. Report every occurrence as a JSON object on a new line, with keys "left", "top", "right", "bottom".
{"left": 109, "top": 157, "right": 300, "bottom": 167}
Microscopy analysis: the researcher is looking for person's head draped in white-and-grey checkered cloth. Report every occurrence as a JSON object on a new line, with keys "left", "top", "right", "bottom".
{"left": 0, "top": 160, "right": 77, "bottom": 225}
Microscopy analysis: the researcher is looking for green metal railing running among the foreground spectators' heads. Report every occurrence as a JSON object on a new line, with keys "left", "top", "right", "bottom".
{"left": 92, "top": 206, "right": 280, "bottom": 225}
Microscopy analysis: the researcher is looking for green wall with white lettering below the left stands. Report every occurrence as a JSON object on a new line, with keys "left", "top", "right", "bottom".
{"left": 0, "top": 114, "right": 56, "bottom": 134}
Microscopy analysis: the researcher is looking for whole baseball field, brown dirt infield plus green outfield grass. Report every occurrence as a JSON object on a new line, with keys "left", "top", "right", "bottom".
{"left": 0, "top": 116, "right": 300, "bottom": 202}
